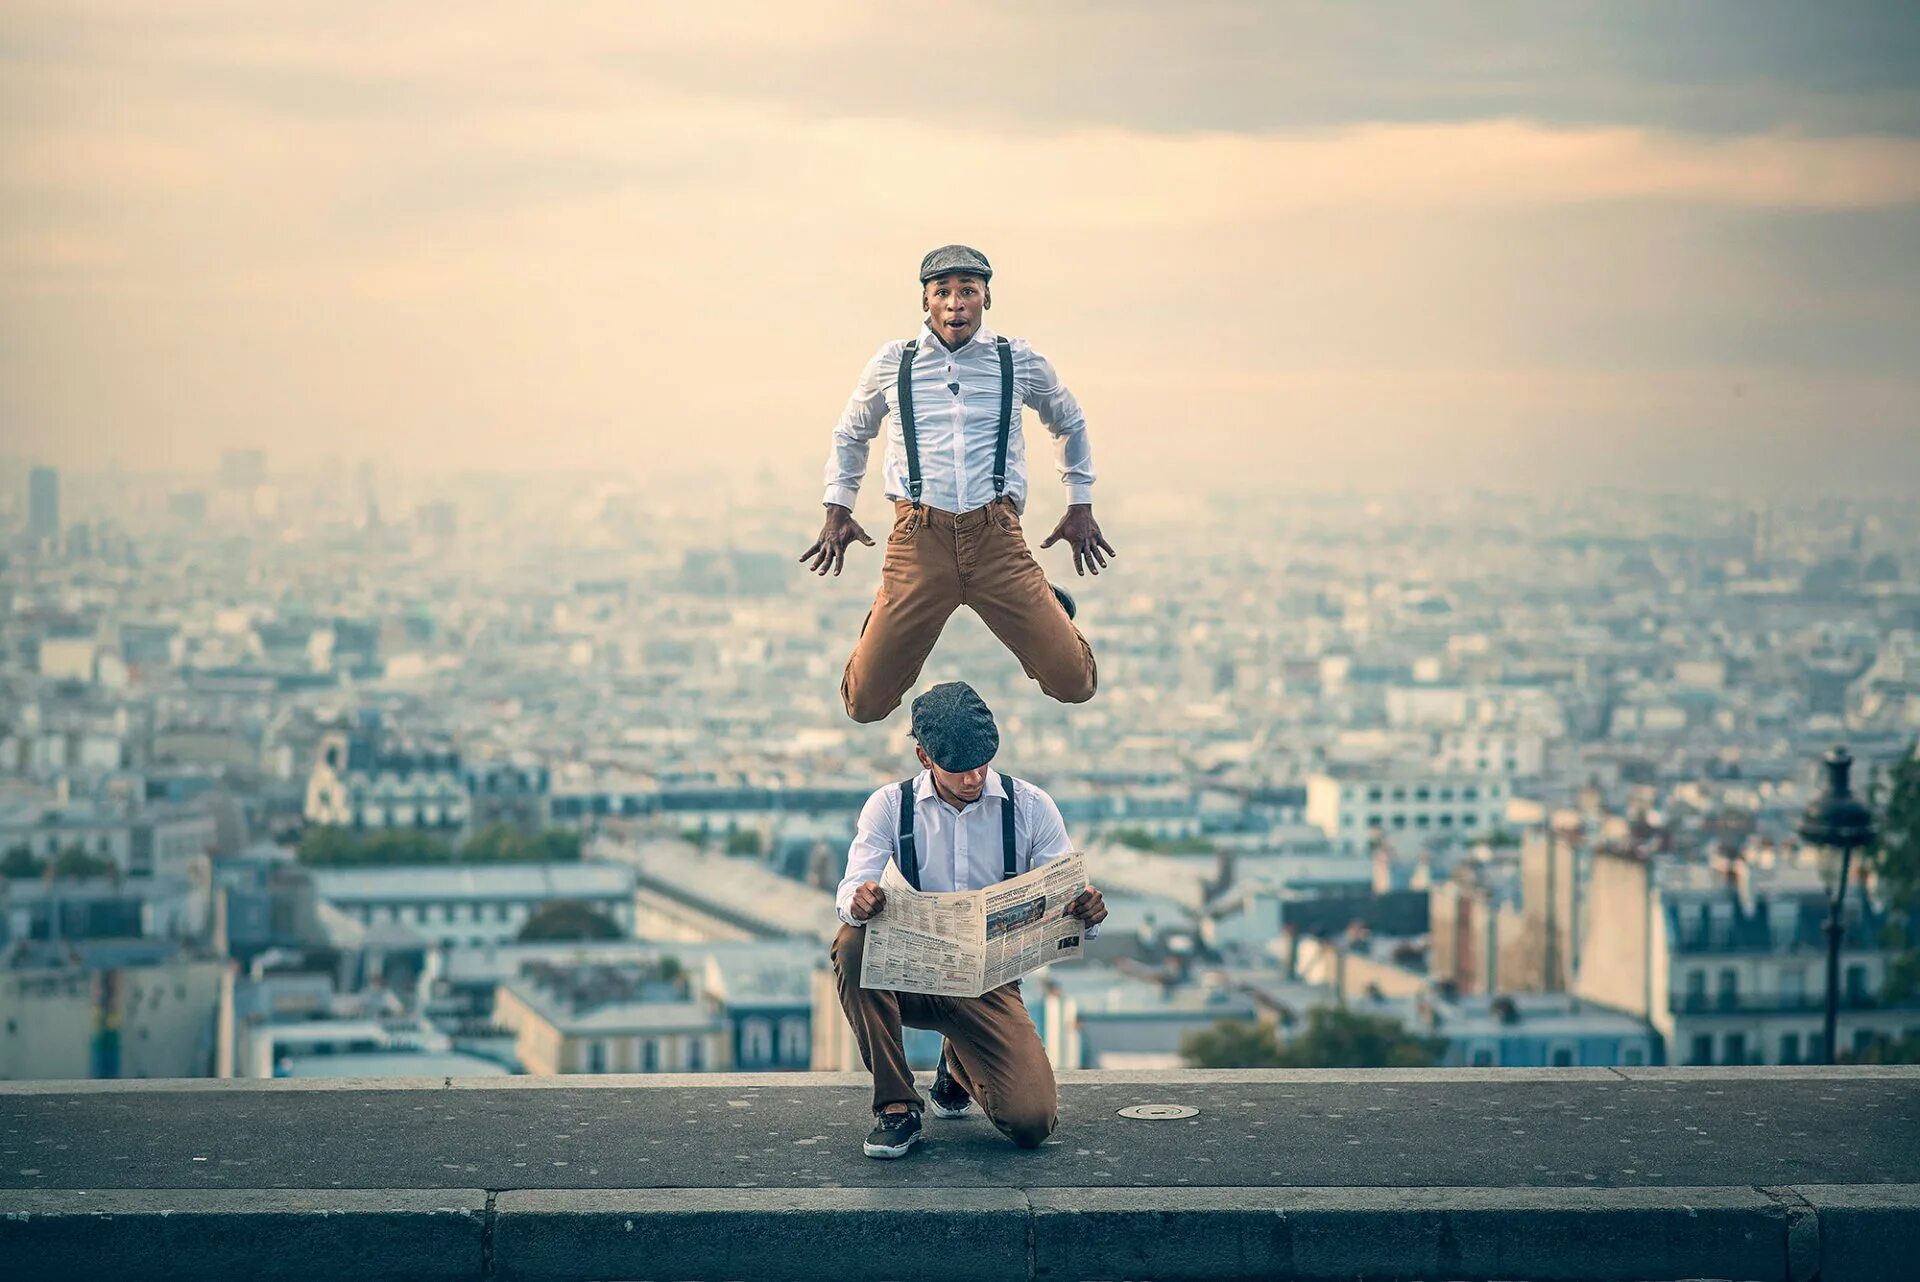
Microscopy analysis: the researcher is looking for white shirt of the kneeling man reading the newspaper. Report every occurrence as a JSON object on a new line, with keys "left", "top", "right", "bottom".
{"left": 835, "top": 770, "right": 1100, "bottom": 938}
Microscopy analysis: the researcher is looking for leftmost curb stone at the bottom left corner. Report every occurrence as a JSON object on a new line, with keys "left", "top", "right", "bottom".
{"left": 0, "top": 1188, "right": 488, "bottom": 1282}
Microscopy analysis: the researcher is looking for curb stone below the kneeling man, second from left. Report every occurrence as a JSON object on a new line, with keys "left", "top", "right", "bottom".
{"left": 493, "top": 1188, "right": 1029, "bottom": 1282}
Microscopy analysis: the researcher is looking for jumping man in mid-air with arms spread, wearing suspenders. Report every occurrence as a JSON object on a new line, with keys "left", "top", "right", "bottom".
{"left": 801, "top": 246, "right": 1114, "bottom": 722}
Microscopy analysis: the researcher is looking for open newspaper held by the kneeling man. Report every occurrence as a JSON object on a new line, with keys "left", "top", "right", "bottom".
{"left": 860, "top": 850, "right": 1087, "bottom": 998}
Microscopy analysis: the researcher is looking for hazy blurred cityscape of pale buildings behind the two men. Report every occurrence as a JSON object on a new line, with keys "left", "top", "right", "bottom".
{"left": 0, "top": 451, "right": 1920, "bottom": 1079}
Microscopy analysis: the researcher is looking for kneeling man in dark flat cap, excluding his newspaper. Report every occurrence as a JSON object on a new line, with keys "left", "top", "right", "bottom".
{"left": 831, "top": 681, "right": 1106, "bottom": 1157}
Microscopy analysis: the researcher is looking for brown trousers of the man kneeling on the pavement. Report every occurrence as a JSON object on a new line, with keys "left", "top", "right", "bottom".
{"left": 829, "top": 925, "right": 1060, "bottom": 1148}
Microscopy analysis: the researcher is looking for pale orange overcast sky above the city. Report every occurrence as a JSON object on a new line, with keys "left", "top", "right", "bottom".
{"left": 0, "top": 0, "right": 1920, "bottom": 503}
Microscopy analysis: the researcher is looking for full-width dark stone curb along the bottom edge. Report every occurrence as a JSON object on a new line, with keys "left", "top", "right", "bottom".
{"left": 0, "top": 1184, "right": 1920, "bottom": 1282}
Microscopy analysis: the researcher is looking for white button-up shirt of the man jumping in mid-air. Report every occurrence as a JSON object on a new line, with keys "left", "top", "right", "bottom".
{"left": 824, "top": 324, "right": 1092, "bottom": 512}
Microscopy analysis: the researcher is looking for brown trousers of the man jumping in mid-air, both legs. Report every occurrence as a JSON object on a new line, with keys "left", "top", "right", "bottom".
{"left": 841, "top": 499, "right": 1098, "bottom": 722}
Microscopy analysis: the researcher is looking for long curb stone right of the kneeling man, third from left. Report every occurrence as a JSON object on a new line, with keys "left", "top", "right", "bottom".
{"left": 1031, "top": 1188, "right": 1788, "bottom": 1282}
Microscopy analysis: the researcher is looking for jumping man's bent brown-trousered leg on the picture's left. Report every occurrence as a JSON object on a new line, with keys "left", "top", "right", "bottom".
{"left": 841, "top": 501, "right": 960, "bottom": 722}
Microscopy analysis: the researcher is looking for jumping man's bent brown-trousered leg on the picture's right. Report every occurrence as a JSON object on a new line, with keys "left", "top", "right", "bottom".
{"left": 966, "top": 501, "right": 1098, "bottom": 702}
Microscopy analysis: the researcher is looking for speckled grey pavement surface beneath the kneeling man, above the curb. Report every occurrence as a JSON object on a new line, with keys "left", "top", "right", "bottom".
{"left": 0, "top": 1073, "right": 1920, "bottom": 1188}
